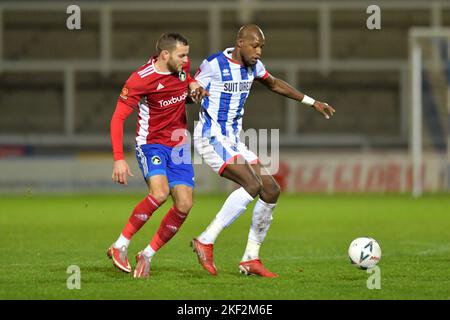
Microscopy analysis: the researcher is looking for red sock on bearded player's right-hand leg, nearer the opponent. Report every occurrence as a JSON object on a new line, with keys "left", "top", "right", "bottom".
{"left": 150, "top": 206, "right": 188, "bottom": 251}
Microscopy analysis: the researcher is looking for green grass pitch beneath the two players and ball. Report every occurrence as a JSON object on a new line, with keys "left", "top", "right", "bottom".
{"left": 0, "top": 194, "right": 450, "bottom": 299}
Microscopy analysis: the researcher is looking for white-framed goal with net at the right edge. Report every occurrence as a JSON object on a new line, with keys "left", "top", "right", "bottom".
{"left": 409, "top": 28, "right": 450, "bottom": 197}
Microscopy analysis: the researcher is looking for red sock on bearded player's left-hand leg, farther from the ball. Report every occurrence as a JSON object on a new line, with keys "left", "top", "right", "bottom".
{"left": 122, "top": 194, "right": 159, "bottom": 240}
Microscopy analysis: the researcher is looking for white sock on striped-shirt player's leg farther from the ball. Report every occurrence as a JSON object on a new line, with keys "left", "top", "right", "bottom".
{"left": 198, "top": 187, "right": 253, "bottom": 244}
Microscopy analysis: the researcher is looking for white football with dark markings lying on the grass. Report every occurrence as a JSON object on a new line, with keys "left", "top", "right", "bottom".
{"left": 348, "top": 237, "right": 381, "bottom": 269}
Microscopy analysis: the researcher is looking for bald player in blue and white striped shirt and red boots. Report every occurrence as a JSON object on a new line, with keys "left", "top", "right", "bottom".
{"left": 192, "top": 24, "right": 335, "bottom": 277}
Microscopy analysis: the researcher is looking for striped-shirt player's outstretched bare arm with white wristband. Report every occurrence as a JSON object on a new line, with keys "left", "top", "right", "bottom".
{"left": 258, "top": 75, "right": 336, "bottom": 119}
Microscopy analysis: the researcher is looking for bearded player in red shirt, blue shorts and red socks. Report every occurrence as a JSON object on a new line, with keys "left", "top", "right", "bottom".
{"left": 108, "top": 33, "right": 208, "bottom": 278}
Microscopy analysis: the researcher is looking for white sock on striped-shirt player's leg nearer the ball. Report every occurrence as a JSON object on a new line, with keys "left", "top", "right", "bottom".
{"left": 242, "top": 199, "right": 276, "bottom": 261}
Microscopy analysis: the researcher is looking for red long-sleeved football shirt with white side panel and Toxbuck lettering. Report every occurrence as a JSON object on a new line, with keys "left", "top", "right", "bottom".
{"left": 111, "top": 57, "right": 194, "bottom": 160}
